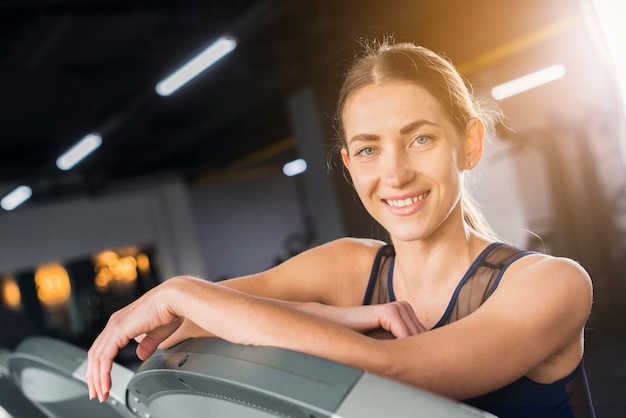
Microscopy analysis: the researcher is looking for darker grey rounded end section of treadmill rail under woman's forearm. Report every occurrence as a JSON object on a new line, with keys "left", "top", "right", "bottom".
{"left": 127, "top": 338, "right": 363, "bottom": 418}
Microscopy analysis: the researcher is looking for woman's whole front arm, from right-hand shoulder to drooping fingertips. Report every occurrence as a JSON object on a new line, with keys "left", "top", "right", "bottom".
{"left": 87, "top": 251, "right": 591, "bottom": 399}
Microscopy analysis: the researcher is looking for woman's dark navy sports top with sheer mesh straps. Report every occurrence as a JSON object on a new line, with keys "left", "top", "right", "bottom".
{"left": 363, "top": 243, "right": 595, "bottom": 418}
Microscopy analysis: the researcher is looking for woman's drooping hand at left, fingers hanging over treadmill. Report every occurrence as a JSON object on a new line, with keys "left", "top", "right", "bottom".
{"left": 86, "top": 282, "right": 182, "bottom": 402}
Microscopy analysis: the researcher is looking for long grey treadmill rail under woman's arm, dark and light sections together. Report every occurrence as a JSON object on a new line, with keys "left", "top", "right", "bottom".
{"left": 127, "top": 339, "right": 493, "bottom": 418}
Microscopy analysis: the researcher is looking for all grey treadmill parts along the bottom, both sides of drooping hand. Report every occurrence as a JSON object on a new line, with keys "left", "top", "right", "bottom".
{"left": 0, "top": 337, "right": 493, "bottom": 418}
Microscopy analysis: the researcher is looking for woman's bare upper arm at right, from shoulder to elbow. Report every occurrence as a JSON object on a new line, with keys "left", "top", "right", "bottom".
{"left": 384, "top": 256, "right": 592, "bottom": 400}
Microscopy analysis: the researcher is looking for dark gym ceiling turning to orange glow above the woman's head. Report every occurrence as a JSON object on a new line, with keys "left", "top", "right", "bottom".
{"left": 0, "top": 0, "right": 607, "bottom": 204}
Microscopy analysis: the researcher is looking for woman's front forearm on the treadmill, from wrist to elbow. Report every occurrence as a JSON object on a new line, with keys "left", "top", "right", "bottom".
{"left": 165, "top": 279, "right": 380, "bottom": 369}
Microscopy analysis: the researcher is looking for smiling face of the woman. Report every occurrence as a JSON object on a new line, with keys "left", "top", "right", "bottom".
{"left": 341, "top": 82, "right": 482, "bottom": 241}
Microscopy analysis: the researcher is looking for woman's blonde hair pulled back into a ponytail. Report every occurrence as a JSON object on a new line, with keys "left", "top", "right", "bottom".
{"left": 335, "top": 39, "right": 502, "bottom": 239}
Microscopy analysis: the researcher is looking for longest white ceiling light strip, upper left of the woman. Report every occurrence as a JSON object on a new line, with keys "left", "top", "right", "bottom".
{"left": 155, "top": 37, "right": 237, "bottom": 96}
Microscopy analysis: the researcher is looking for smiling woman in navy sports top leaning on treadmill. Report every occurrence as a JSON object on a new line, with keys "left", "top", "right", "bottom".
{"left": 87, "top": 43, "right": 593, "bottom": 417}
